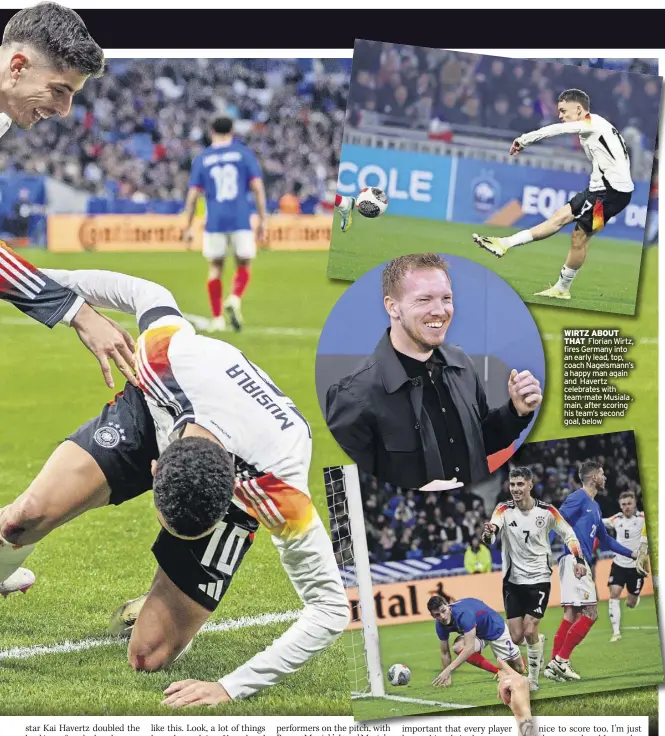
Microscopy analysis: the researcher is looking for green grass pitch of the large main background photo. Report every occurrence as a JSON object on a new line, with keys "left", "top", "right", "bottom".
{"left": 0, "top": 246, "right": 658, "bottom": 715}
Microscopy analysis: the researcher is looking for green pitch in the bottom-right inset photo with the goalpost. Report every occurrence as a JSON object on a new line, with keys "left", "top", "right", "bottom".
{"left": 353, "top": 597, "right": 663, "bottom": 720}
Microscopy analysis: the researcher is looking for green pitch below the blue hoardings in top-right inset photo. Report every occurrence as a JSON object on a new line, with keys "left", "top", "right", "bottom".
{"left": 328, "top": 214, "right": 642, "bottom": 314}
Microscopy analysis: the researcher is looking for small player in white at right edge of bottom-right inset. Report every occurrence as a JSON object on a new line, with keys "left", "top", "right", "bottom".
{"left": 603, "top": 491, "right": 645, "bottom": 642}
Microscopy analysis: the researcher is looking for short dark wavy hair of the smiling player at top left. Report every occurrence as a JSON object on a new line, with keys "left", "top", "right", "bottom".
{"left": 2, "top": 3, "right": 104, "bottom": 77}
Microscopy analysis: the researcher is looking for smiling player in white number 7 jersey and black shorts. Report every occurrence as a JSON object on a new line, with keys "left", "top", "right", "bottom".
{"left": 482, "top": 468, "right": 587, "bottom": 690}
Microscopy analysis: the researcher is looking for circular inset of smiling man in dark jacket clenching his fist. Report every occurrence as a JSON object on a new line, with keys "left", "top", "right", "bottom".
{"left": 316, "top": 253, "right": 545, "bottom": 490}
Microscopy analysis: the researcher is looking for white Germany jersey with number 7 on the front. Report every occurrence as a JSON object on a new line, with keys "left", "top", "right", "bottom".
{"left": 490, "top": 499, "right": 580, "bottom": 585}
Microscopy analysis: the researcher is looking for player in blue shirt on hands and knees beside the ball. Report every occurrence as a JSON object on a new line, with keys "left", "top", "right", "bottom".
{"left": 427, "top": 595, "right": 526, "bottom": 687}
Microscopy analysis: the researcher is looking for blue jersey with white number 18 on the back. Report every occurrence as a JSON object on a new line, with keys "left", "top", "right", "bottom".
{"left": 189, "top": 139, "right": 261, "bottom": 233}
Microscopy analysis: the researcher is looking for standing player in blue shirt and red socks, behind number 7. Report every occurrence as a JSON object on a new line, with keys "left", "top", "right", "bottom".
{"left": 543, "top": 460, "right": 646, "bottom": 681}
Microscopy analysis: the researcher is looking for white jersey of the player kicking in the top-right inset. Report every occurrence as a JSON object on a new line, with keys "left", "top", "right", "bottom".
{"left": 517, "top": 113, "right": 635, "bottom": 192}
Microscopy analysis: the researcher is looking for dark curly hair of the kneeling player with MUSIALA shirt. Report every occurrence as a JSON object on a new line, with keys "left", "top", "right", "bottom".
{"left": 153, "top": 437, "right": 235, "bottom": 537}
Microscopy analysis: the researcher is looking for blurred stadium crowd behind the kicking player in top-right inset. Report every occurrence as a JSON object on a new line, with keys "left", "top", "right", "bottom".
{"left": 347, "top": 40, "right": 660, "bottom": 158}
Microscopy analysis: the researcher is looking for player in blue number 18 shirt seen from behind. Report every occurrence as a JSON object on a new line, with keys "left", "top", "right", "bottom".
{"left": 183, "top": 118, "right": 266, "bottom": 332}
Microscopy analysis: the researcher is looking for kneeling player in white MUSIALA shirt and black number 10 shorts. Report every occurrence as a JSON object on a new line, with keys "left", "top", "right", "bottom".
{"left": 0, "top": 270, "right": 349, "bottom": 707}
